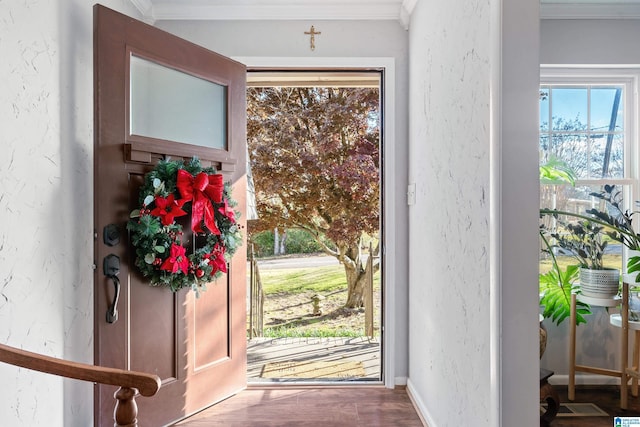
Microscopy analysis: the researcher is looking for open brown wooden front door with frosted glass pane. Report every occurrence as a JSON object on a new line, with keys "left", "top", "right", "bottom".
{"left": 94, "top": 5, "right": 246, "bottom": 426}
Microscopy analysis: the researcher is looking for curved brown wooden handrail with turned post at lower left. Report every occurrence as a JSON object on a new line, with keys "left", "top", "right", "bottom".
{"left": 0, "top": 344, "right": 161, "bottom": 426}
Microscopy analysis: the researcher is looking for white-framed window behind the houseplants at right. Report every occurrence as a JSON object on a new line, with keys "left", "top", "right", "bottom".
{"left": 539, "top": 69, "right": 638, "bottom": 271}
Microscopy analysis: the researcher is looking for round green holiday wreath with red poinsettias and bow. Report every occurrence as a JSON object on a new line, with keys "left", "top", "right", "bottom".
{"left": 127, "top": 158, "right": 242, "bottom": 293}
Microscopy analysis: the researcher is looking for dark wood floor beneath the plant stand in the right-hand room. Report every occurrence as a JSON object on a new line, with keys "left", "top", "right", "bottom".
{"left": 551, "top": 385, "right": 640, "bottom": 427}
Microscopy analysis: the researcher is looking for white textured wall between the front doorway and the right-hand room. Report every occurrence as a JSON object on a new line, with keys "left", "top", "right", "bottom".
{"left": 409, "top": 1, "right": 491, "bottom": 427}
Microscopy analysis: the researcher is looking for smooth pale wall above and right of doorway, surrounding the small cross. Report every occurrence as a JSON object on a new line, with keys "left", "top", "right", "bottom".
{"left": 156, "top": 21, "right": 408, "bottom": 382}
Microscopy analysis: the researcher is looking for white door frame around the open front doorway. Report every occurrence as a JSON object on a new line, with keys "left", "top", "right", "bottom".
{"left": 231, "top": 56, "right": 396, "bottom": 388}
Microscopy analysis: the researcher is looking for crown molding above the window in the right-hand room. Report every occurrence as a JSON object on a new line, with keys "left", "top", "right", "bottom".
{"left": 540, "top": 2, "right": 640, "bottom": 19}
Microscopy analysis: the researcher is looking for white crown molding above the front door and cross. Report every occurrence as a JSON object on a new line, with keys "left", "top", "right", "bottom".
{"left": 131, "top": 0, "right": 417, "bottom": 28}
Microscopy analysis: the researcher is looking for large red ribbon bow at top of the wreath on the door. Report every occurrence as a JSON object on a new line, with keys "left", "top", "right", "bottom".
{"left": 176, "top": 169, "right": 224, "bottom": 235}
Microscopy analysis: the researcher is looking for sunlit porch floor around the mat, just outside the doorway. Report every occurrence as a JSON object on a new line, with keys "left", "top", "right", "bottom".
{"left": 247, "top": 337, "right": 381, "bottom": 384}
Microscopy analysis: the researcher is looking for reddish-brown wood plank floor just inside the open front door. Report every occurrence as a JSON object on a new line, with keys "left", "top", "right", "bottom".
{"left": 176, "top": 386, "right": 423, "bottom": 427}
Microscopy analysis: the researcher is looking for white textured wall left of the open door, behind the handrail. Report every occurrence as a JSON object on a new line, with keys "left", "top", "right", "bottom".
{"left": 0, "top": 0, "right": 141, "bottom": 427}
